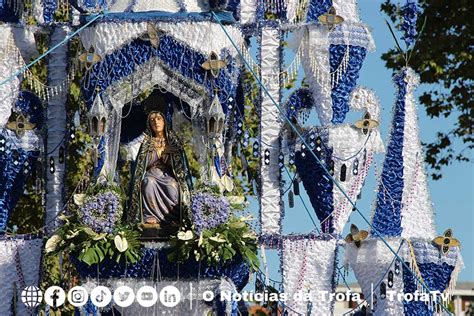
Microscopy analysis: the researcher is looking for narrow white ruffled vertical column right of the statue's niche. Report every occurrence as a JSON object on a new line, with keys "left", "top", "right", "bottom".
{"left": 260, "top": 27, "right": 282, "bottom": 234}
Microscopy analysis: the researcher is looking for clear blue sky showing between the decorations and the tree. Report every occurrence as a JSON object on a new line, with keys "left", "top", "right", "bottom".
{"left": 251, "top": 0, "right": 474, "bottom": 282}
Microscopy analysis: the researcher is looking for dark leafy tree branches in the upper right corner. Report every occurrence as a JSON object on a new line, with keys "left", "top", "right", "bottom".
{"left": 381, "top": 0, "right": 474, "bottom": 180}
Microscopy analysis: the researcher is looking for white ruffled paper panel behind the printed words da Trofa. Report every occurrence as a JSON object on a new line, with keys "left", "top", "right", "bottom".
{"left": 282, "top": 236, "right": 336, "bottom": 315}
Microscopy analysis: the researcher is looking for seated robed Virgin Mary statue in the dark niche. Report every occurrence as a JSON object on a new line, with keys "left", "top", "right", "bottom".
{"left": 127, "top": 111, "right": 192, "bottom": 232}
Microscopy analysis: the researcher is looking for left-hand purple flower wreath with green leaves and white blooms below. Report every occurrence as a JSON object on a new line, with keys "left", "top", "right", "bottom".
{"left": 45, "top": 184, "right": 140, "bottom": 265}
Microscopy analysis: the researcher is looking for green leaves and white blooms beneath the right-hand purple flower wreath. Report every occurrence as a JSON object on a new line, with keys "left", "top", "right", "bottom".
{"left": 168, "top": 216, "right": 259, "bottom": 271}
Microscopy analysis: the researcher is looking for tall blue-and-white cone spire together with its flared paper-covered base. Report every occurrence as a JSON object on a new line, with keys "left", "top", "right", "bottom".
{"left": 345, "top": 68, "right": 463, "bottom": 315}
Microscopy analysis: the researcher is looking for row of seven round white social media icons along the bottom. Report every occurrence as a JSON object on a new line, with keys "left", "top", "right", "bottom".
{"left": 21, "top": 285, "right": 181, "bottom": 308}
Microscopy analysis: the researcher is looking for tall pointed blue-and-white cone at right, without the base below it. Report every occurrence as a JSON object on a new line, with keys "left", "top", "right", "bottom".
{"left": 372, "top": 68, "right": 435, "bottom": 238}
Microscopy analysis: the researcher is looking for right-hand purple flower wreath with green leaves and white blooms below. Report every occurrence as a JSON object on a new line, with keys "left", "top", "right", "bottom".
{"left": 168, "top": 187, "right": 259, "bottom": 270}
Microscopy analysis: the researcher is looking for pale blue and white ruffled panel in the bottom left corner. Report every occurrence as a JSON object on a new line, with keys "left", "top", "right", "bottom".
{"left": 0, "top": 236, "right": 43, "bottom": 315}
